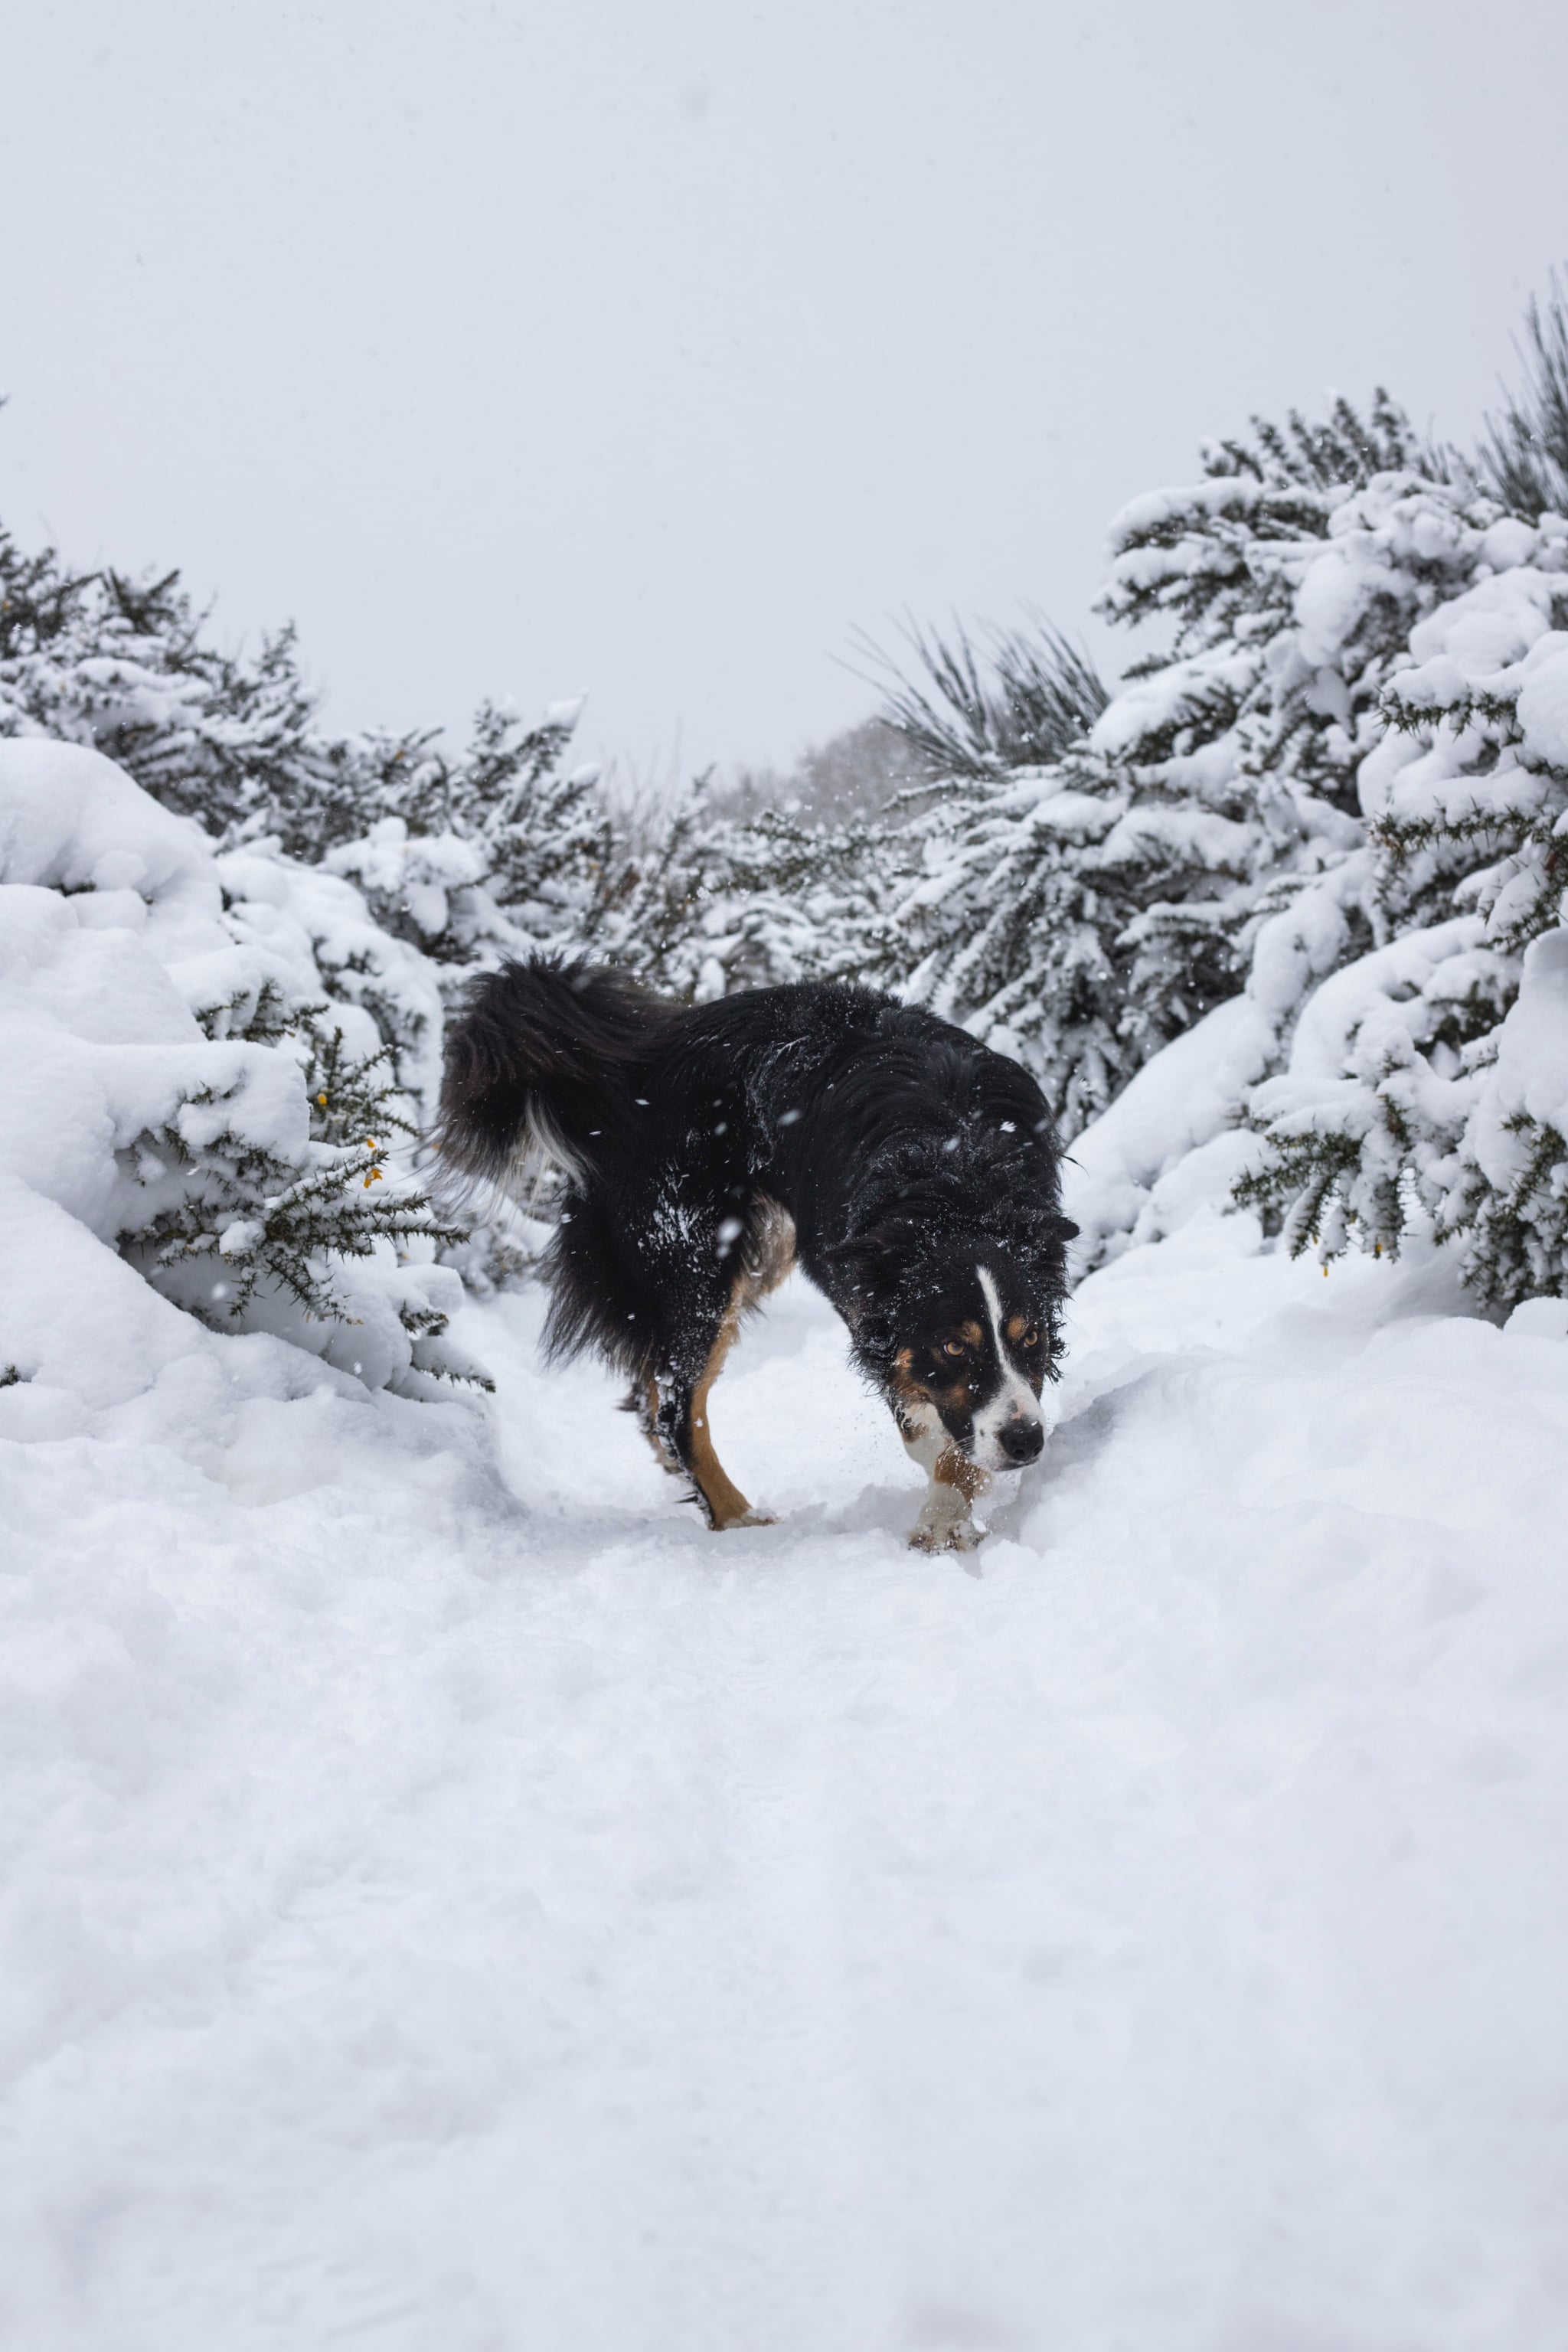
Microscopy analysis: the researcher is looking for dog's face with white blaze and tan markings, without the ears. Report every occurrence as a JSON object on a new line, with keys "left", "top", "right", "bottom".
{"left": 893, "top": 1266, "right": 1046, "bottom": 1470}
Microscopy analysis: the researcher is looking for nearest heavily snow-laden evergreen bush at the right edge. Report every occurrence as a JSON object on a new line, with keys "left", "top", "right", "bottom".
{"left": 1243, "top": 529, "right": 1568, "bottom": 1301}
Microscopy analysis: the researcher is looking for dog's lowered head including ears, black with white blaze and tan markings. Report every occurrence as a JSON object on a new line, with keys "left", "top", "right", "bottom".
{"left": 851, "top": 1240, "right": 1060, "bottom": 1470}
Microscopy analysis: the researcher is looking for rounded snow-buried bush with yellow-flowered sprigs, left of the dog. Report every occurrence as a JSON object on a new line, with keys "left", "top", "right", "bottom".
{"left": 0, "top": 741, "right": 484, "bottom": 1395}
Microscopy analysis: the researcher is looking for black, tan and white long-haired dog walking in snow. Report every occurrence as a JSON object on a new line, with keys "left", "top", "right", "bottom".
{"left": 435, "top": 955, "right": 1076, "bottom": 1553}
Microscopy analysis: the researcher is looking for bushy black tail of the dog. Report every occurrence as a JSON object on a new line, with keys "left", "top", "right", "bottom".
{"left": 435, "top": 955, "right": 675, "bottom": 1183}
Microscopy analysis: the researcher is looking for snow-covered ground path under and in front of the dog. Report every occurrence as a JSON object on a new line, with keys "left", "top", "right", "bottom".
{"left": 0, "top": 1226, "right": 1568, "bottom": 2352}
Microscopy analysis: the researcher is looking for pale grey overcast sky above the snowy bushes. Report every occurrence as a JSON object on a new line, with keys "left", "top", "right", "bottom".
{"left": 0, "top": 0, "right": 1568, "bottom": 774}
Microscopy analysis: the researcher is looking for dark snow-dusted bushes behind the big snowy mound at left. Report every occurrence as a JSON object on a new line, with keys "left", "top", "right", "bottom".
{"left": 0, "top": 531, "right": 621, "bottom": 1025}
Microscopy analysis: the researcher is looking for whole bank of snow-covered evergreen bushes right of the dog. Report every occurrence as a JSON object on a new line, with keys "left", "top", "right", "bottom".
{"left": 870, "top": 303, "right": 1568, "bottom": 1303}
